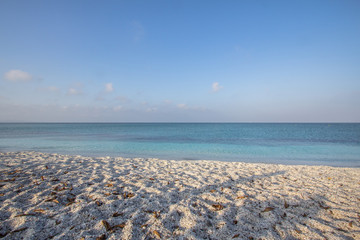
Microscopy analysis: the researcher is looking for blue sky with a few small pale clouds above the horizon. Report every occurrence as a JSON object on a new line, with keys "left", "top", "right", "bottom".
{"left": 0, "top": 0, "right": 360, "bottom": 122}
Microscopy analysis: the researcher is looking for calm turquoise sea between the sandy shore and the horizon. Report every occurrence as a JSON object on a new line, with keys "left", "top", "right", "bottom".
{"left": 0, "top": 123, "right": 360, "bottom": 167}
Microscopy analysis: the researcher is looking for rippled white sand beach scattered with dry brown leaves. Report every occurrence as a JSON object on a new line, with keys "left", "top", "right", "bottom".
{"left": 0, "top": 152, "right": 360, "bottom": 239}
